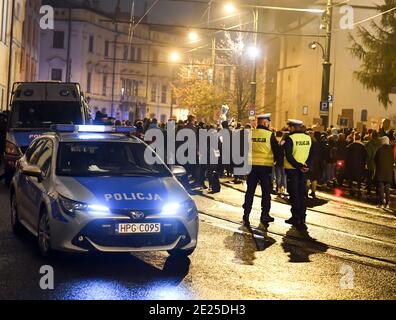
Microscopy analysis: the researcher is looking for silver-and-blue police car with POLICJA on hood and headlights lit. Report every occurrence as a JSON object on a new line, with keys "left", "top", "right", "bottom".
{"left": 10, "top": 125, "right": 198, "bottom": 256}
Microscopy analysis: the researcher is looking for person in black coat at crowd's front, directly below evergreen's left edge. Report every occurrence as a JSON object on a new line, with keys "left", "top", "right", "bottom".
{"left": 345, "top": 132, "right": 367, "bottom": 195}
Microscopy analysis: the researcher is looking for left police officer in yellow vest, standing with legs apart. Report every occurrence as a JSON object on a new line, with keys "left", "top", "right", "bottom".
{"left": 243, "top": 114, "right": 279, "bottom": 226}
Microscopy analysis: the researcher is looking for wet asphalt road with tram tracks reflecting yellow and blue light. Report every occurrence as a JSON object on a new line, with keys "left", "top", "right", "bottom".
{"left": 0, "top": 181, "right": 396, "bottom": 299}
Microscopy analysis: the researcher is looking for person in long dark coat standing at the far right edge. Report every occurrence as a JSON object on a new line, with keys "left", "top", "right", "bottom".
{"left": 374, "top": 136, "right": 395, "bottom": 209}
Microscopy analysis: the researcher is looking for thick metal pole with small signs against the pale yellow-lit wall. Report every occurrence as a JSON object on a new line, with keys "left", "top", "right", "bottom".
{"left": 321, "top": 0, "right": 333, "bottom": 128}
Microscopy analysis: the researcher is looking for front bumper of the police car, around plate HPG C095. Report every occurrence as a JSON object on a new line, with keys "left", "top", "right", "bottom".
{"left": 50, "top": 213, "right": 199, "bottom": 252}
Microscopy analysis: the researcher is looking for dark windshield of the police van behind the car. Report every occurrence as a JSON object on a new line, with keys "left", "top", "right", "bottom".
{"left": 10, "top": 101, "right": 83, "bottom": 129}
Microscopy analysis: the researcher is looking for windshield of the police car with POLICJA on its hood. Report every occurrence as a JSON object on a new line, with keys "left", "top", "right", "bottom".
{"left": 56, "top": 141, "right": 171, "bottom": 177}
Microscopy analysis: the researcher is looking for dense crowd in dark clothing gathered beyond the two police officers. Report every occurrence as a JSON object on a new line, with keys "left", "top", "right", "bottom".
{"left": 94, "top": 110, "right": 396, "bottom": 208}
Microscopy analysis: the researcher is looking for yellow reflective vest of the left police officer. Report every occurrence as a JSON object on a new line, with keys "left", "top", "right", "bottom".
{"left": 251, "top": 129, "right": 274, "bottom": 167}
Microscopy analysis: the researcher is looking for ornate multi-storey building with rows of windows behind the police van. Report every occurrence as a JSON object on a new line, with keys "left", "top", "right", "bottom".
{"left": 39, "top": 6, "right": 188, "bottom": 122}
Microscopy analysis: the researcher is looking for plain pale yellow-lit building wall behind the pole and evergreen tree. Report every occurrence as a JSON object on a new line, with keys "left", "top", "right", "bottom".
{"left": 259, "top": 0, "right": 396, "bottom": 128}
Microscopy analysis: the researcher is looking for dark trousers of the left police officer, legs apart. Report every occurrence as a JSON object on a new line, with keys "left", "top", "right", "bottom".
{"left": 243, "top": 166, "right": 272, "bottom": 215}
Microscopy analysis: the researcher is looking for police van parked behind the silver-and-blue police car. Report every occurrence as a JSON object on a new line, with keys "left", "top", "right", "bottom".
{"left": 4, "top": 82, "right": 92, "bottom": 185}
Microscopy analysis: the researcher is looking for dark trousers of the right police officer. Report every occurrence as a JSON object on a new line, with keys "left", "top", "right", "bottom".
{"left": 286, "top": 169, "right": 307, "bottom": 220}
